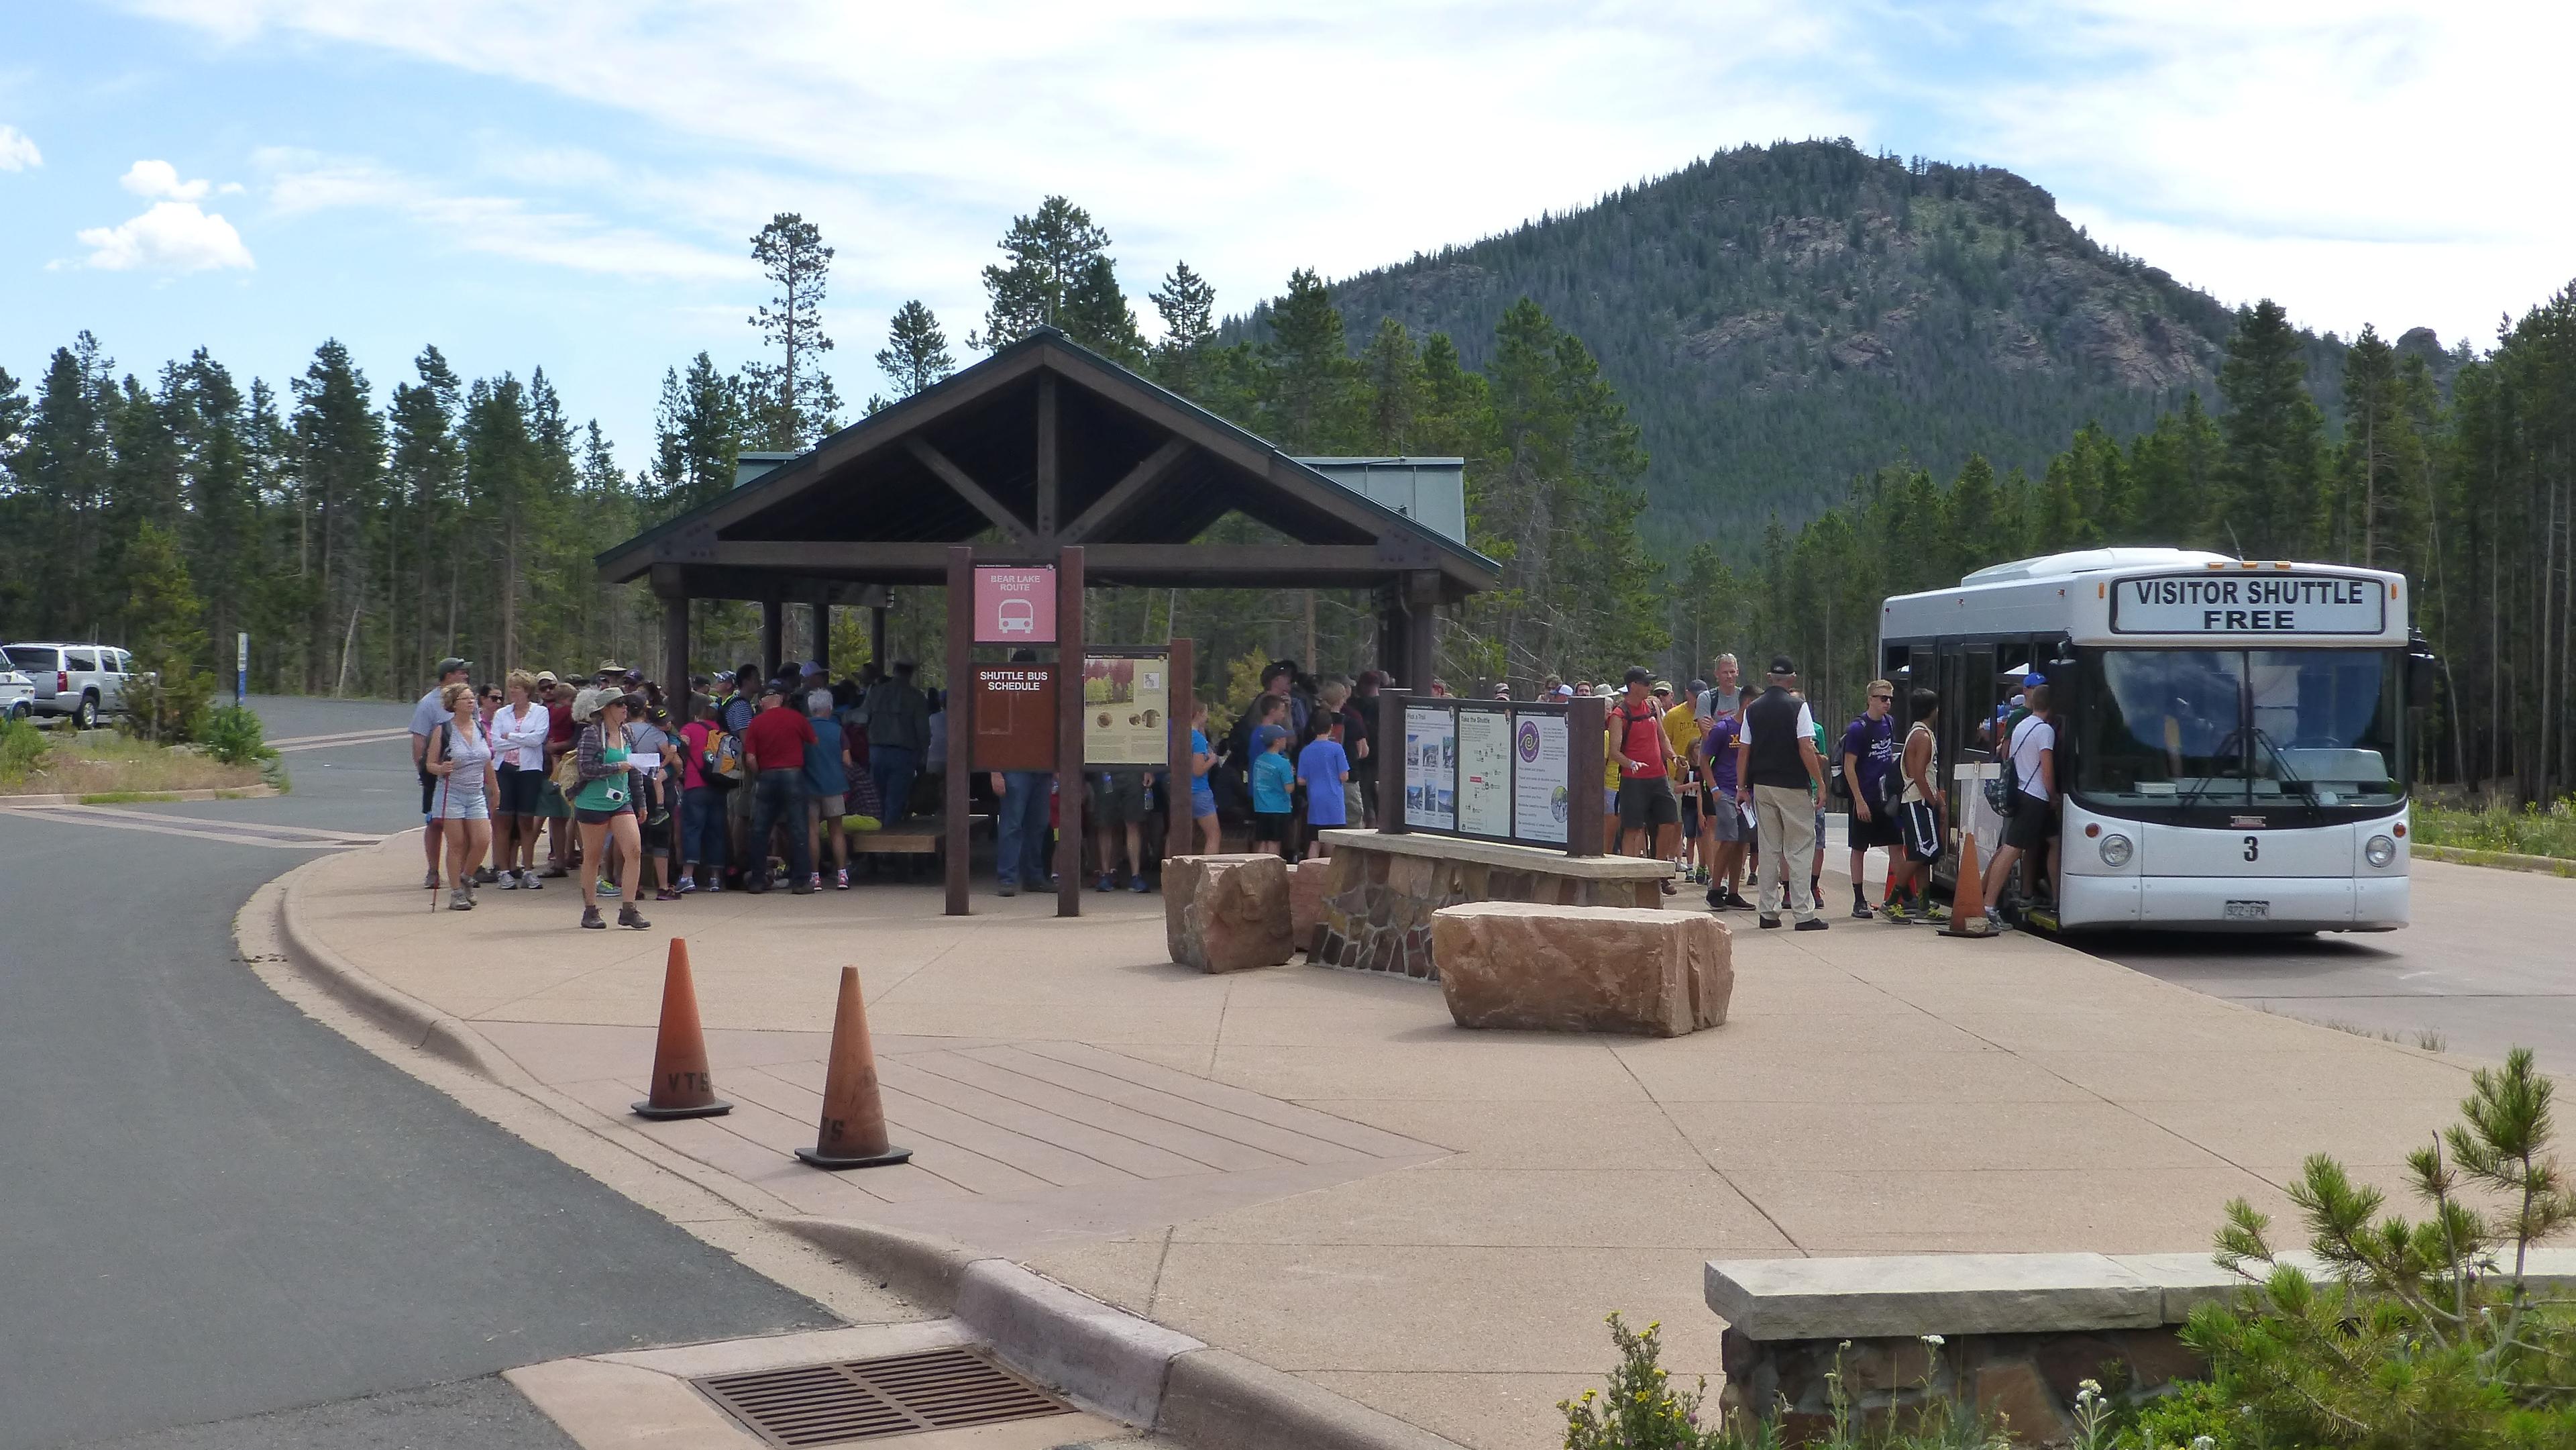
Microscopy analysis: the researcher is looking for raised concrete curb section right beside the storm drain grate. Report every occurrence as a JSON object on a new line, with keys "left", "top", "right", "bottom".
{"left": 763, "top": 1219, "right": 1460, "bottom": 1450}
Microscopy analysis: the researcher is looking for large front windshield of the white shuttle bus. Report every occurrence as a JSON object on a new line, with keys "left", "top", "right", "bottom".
{"left": 2074, "top": 649, "right": 2406, "bottom": 809}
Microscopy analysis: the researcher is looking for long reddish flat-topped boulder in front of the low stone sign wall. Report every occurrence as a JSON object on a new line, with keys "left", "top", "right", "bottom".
{"left": 1432, "top": 901, "right": 1736, "bottom": 1038}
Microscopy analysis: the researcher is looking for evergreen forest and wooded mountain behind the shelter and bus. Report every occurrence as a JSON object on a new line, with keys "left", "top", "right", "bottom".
{"left": 0, "top": 159, "right": 2576, "bottom": 798}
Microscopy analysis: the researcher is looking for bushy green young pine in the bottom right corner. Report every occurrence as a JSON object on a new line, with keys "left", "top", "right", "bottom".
{"left": 2182, "top": 1048, "right": 2576, "bottom": 1450}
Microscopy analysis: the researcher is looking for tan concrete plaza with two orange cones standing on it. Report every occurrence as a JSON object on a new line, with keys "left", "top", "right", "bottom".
{"left": 294, "top": 837, "right": 2465, "bottom": 1450}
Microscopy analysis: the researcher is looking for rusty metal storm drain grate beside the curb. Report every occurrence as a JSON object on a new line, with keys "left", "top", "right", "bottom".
{"left": 696, "top": 1349, "right": 1071, "bottom": 1445}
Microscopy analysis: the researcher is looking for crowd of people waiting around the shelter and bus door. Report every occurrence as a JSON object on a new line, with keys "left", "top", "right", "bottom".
{"left": 410, "top": 641, "right": 2055, "bottom": 930}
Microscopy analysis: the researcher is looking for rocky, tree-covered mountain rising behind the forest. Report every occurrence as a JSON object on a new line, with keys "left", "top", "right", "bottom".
{"left": 1246, "top": 142, "right": 2457, "bottom": 538}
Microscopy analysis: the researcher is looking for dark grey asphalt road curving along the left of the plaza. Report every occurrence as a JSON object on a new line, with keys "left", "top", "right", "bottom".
{"left": 0, "top": 701, "right": 832, "bottom": 1450}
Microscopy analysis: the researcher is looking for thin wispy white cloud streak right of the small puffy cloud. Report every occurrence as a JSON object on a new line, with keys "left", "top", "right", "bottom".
{"left": 258, "top": 150, "right": 752, "bottom": 280}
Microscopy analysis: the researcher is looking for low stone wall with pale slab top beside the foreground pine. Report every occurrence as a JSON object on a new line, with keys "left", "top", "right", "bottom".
{"left": 1703, "top": 1249, "right": 2576, "bottom": 1445}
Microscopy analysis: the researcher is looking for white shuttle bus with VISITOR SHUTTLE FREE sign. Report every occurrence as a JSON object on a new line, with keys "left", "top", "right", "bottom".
{"left": 1878, "top": 549, "right": 2434, "bottom": 932}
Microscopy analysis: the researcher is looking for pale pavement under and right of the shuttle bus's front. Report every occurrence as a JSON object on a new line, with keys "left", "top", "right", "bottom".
{"left": 2069, "top": 860, "right": 2576, "bottom": 1072}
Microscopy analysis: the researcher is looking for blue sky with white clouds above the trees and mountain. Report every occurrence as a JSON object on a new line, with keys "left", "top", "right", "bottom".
{"left": 0, "top": 0, "right": 2576, "bottom": 476}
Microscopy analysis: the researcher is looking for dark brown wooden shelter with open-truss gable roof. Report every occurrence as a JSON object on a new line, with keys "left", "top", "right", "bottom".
{"left": 598, "top": 327, "right": 1499, "bottom": 909}
